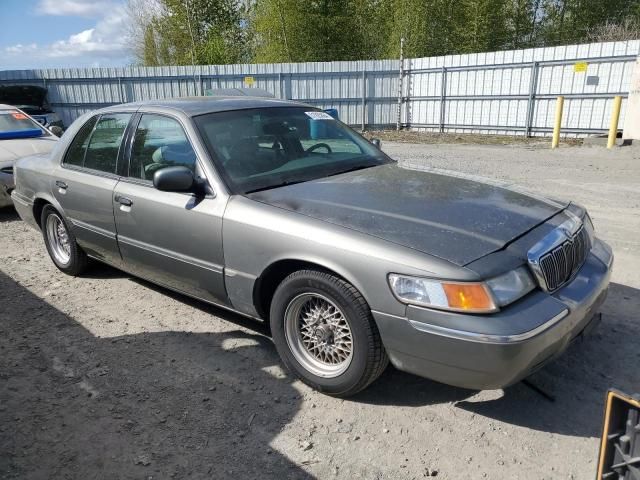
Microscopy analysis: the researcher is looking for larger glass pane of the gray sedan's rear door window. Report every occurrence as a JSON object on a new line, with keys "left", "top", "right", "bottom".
{"left": 83, "top": 113, "right": 131, "bottom": 173}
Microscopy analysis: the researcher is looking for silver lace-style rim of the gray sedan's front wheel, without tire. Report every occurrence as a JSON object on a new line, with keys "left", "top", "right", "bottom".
{"left": 284, "top": 293, "right": 353, "bottom": 378}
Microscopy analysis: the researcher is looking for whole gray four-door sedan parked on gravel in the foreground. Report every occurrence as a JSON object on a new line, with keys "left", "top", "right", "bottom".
{"left": 12, "top": 97, "right": 613, "bottom": 396}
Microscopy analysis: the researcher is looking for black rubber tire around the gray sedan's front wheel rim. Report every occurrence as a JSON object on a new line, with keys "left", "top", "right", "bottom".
{"left": 270, "top": 270, "right": 389, "bottom": 397}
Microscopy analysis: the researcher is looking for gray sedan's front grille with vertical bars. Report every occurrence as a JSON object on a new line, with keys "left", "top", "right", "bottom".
{"left": 538, "top": 226, "right": 591, "bottom": 292}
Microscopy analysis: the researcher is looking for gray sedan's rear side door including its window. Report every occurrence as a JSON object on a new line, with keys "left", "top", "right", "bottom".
{"left": 52, "top": 113, "right": 131, "bottom": 265}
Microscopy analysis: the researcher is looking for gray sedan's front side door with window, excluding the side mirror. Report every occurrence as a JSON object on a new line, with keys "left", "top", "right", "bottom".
{"left": 113, "top": 114, "right": 228, "bottom": 305}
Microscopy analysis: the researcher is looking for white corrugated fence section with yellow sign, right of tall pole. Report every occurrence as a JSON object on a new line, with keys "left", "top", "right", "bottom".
{"left": 403, "top": 40, "right": 640, "bottom": 135}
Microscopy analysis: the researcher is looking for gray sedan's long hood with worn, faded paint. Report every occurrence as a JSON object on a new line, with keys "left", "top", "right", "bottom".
{"left": 247, "top": 164, "right": 567, "bottom": 266}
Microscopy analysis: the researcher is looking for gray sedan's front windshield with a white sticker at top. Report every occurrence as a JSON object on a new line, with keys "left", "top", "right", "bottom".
{"left": 195, "top": 107, "right": 392, "bottom": 193}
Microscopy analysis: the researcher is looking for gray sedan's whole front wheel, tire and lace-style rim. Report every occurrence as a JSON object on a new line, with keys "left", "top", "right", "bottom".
{"left": 270, "top": 270, "right": 389, "bottom": 397}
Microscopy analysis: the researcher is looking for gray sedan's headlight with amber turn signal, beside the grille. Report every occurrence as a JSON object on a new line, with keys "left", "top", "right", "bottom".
{"left": 389, "top": 267, "right": 535, "bottom": 313}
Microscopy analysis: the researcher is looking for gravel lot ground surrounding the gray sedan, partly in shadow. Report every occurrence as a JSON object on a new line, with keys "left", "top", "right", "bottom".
{"left": 0, "top": 143, "right": 640, "bottom": 479}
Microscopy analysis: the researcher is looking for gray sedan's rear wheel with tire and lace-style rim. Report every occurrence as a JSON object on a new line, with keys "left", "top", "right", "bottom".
{"left": 40, "top": 205, "right": 88, "bottom": 276}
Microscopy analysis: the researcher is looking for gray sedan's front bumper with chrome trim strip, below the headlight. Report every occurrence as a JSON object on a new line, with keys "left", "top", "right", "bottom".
{"left": 373, "top": 240, "right": 613, "bottom": 390}
